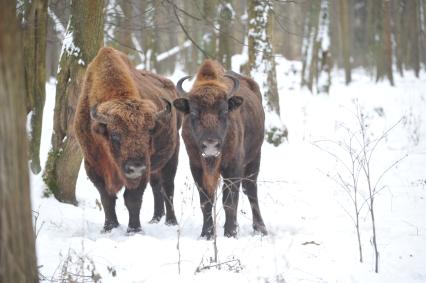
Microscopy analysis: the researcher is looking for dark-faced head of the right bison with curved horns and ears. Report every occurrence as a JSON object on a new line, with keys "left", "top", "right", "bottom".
{"left": 173, "top": 75, "right": 243, "bottom": 159}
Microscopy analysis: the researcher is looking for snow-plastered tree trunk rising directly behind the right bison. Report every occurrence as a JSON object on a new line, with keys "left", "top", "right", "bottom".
{"left": 248, "top": 0, "right": 287, "bottom": 145}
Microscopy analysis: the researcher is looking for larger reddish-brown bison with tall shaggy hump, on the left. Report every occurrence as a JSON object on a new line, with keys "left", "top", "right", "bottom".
{"left": 74, "top": 48, "right": 181, "bottom": 232}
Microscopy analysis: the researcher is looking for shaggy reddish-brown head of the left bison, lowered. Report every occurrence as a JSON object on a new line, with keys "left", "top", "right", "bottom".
{"left": 90, "top": 99, "right": 171, "bottom": 188}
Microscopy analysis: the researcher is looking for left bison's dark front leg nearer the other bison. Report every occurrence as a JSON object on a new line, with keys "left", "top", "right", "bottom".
{"left": 124, "top": 183, "right": 146, "bottom": 233}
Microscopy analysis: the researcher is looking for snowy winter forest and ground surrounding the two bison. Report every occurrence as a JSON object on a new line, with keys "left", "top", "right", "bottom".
{"left": 0, "top": 0, "right": 426, "bottom": 282}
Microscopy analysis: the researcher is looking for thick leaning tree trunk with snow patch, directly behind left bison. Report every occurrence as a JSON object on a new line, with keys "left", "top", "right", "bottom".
{"left": 43, "top": 0, "right": 104, "bottom": 204}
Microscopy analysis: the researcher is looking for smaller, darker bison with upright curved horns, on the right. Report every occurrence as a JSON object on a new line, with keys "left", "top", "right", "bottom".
{"left": 173, "top": 60, "right": 267, "bottom": 239}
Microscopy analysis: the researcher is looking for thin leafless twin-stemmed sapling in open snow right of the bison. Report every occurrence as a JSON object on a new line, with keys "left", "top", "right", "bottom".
{"left": 314, "top": 103, "right": 407, "bottom": 273}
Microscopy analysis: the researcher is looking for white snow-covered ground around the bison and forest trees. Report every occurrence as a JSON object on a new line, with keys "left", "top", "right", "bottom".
{"left": 31, "top": 60, "right": 426, "bottom": 283}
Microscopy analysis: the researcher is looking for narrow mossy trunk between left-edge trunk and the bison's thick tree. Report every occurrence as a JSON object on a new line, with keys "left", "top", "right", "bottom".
{"left": 23, "top": 0, "right": 47, "bottom": 174}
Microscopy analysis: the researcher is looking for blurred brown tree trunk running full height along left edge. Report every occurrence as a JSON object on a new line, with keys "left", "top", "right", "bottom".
{"left": 0, "top": 0, "right": 38, "bottom": 283}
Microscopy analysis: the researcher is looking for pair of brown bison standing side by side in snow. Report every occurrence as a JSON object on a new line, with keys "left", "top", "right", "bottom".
{"left": 74, "top": 47, "right": 267, "bottom": 239}
